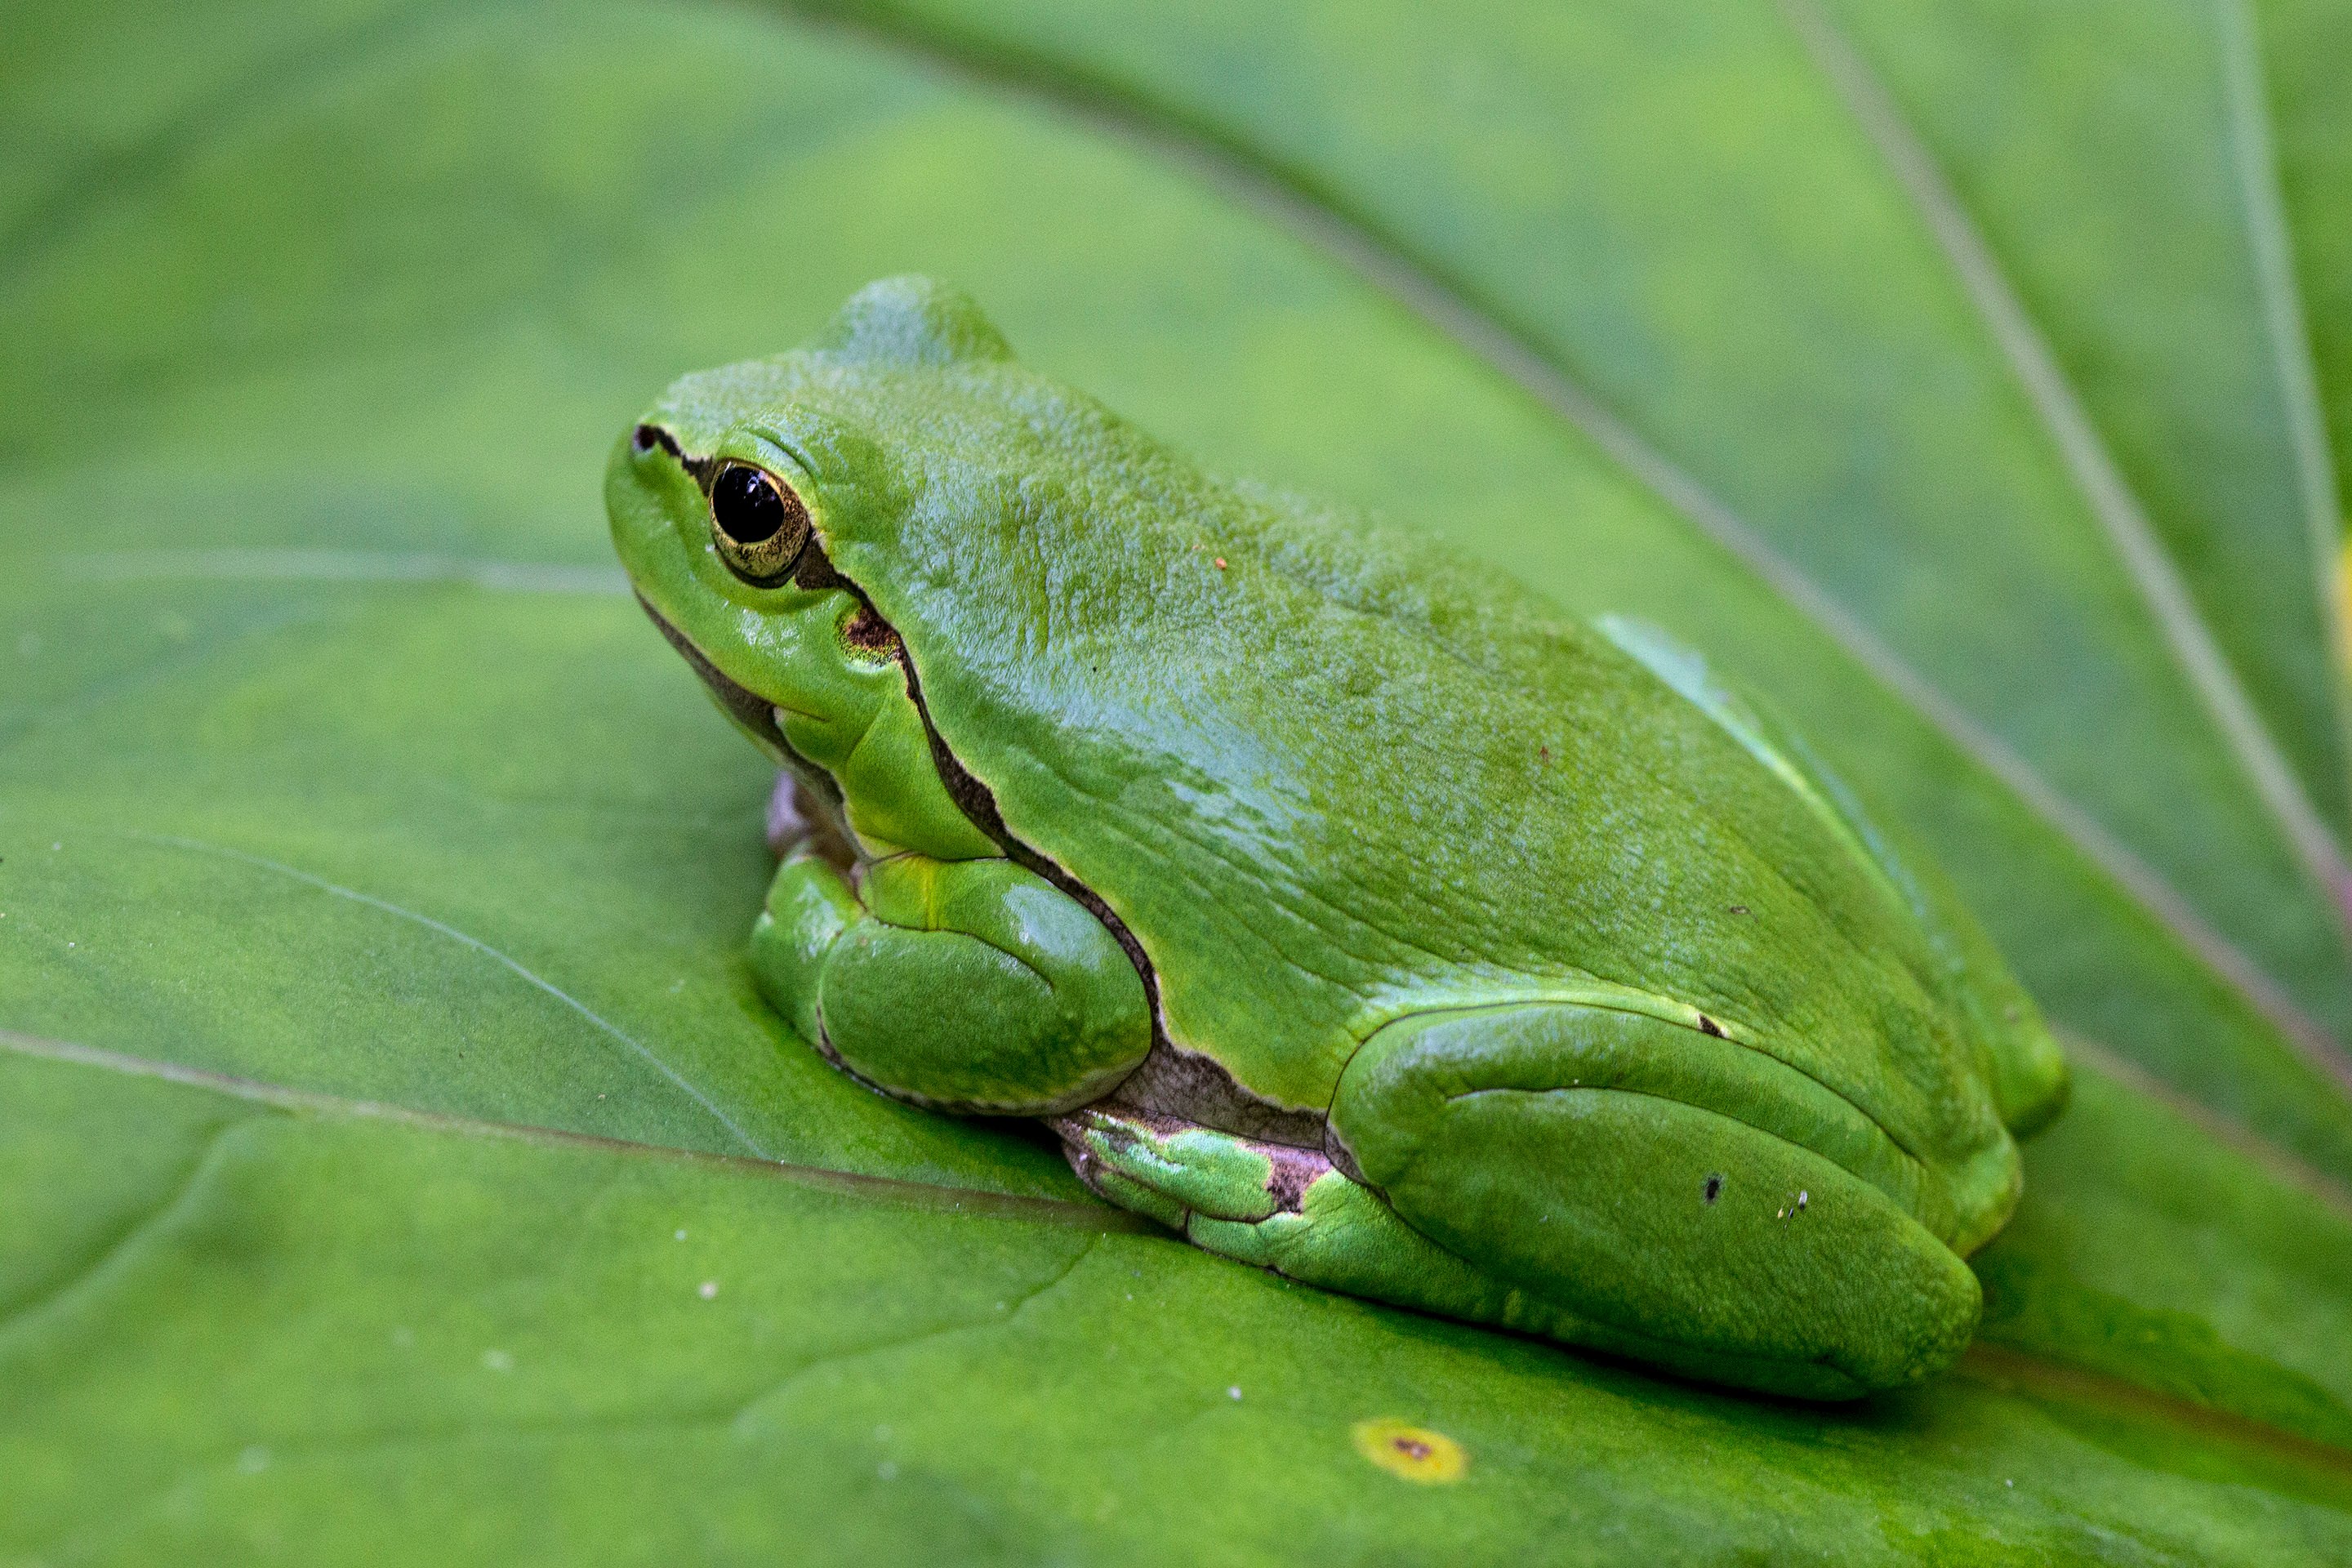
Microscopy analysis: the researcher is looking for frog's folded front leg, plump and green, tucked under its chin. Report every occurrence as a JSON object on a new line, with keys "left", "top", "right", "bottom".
{"left": 751, "top": 849, "right": 1152, "bottom": 1114}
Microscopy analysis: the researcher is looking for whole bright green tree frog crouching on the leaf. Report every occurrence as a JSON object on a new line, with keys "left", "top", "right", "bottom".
{"left": 607, "top": 278, "right": 2068, "bottom": 1399}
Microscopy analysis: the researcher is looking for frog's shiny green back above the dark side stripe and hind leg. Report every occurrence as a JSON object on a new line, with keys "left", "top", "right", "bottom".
{"left": 800, "top": 359, "right": 1999, "bottom": 1189}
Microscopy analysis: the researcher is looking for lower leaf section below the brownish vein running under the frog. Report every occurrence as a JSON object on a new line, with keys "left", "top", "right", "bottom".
{"left": 0, "top": 1058, "right": 2352, "bottom": 1563}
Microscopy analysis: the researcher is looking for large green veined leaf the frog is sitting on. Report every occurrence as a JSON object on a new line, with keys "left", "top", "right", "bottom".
{"left": 13, "top": 0, "right": 2352, "bottom": 1563}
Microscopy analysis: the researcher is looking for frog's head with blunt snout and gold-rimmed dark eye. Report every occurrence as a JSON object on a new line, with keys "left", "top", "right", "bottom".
{"left": 604, "top": 278, "right": 1040, "bottom": 865}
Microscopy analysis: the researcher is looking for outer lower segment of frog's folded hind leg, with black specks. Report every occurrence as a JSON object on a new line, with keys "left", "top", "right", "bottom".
{"left": 1331, "top": 1009, "right": 1980, "bottom": 1396}
